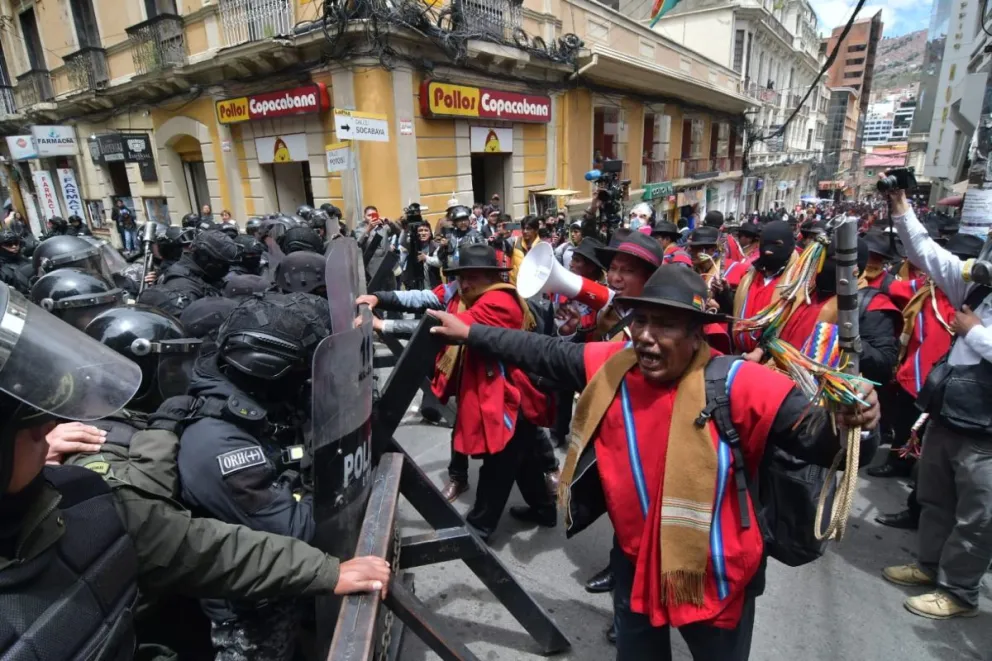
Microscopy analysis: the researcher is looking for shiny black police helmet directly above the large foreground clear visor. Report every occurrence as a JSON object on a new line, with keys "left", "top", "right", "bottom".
{"left": 31, "top": 269, "right": 127, "bottom": 330}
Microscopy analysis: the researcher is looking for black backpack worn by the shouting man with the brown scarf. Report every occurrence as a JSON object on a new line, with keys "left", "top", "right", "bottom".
{"left": 697, "top": 356, "right": 837, "bottom": 567}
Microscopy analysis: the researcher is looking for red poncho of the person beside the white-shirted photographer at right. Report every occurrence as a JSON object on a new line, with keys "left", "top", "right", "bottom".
{"left": 896, "top": 280, "right": 955, "bottom": 397}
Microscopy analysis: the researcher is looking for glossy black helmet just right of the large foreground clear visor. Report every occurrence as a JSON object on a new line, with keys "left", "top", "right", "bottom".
{"left": 86, "top": 305, "right": 201, "bottom": 412}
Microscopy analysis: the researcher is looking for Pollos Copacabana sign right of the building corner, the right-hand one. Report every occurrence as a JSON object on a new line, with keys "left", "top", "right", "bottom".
{"left": 420, "top": 81, "right": 551, "bottom": 123}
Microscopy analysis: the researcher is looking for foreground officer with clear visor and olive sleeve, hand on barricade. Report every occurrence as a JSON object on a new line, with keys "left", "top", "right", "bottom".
{"left": 0, "top": 285, "right": 389, "bottom": 660}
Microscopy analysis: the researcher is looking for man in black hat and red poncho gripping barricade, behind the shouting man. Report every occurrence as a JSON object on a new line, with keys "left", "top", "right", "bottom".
{"left": 358, "top": 243, "right": 557, "bottom": 539}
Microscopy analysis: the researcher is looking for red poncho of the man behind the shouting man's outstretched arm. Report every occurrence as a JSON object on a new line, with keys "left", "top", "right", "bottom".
{"left": 431, "top": 285, "right": 552, "bottom": 455}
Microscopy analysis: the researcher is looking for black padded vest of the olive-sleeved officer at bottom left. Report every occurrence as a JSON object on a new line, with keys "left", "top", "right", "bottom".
{"left": 0, "top": 466, "right": 138, "bottom": 661}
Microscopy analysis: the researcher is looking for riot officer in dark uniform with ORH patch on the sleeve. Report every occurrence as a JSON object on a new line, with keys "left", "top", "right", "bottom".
{"left": 179, "top": 294, "right": 330, "bottom": 660}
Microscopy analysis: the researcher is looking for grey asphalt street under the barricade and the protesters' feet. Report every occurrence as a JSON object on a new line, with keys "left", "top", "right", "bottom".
{"left": 397, "top": 414, "right": 992, "bottom": 661}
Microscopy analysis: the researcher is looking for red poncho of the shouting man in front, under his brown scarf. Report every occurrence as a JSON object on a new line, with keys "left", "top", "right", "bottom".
{"left": 585, "top": 342, "right": 793, "bottom": 629}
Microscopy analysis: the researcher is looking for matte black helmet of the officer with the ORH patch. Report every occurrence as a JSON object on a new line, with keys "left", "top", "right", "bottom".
{"left": 217, "top": 294, "right": 331, "bottom": 383}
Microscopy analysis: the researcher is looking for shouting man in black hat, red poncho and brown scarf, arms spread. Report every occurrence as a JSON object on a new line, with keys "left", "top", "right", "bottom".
{"left": 433, "top": 265, "right": 878, "bottom": 661}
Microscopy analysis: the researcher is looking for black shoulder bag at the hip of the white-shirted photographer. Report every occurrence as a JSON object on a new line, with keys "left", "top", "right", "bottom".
{"left": 916, "top": 286, "right": 992, "bottom": 437}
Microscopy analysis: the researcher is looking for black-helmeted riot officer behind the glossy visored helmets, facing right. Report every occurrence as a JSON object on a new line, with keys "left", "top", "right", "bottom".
{"left": 138, "top": 231, "right": 241, "bottom": 315}
